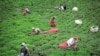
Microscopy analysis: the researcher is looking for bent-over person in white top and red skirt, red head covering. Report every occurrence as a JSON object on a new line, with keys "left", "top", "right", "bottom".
{"left": 59, "top": 37, "right": 78, "bottom": 49}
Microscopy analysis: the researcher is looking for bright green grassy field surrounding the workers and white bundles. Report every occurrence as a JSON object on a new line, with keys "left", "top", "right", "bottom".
{"left": 0, "top": 0, "right": 100, "bottom": 56}
